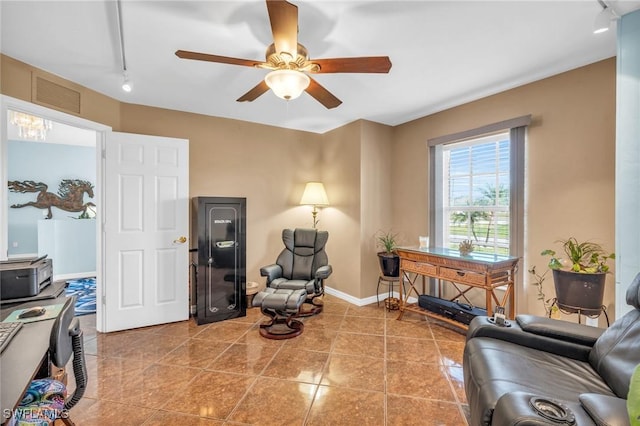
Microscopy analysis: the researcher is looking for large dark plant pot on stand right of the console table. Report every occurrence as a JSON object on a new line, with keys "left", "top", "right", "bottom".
{"left": 553, "top": 269, "right": 607, "bottom": 315}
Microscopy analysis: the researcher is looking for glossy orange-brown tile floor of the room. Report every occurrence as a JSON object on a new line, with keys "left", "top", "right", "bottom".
{"left": 69, "top": 295, "right": 468, "bottom": 426}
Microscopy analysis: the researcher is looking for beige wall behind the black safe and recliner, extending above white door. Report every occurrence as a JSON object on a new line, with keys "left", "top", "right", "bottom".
{"left": 121, "top": 104, "right": 322, "bottom": 283}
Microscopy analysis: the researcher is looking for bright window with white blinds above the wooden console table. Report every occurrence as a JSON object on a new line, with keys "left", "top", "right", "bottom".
{"left": 436, "top": 132, "right": 510, "bottom": 255}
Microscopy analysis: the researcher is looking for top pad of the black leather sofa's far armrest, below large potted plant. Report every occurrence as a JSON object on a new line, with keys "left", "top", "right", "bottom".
{"left": 516, "top": 315, "right": 604, "bottom": 346}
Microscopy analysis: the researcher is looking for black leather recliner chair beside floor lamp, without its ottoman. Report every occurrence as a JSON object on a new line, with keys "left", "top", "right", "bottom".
{"left": 260, "top": 228, "right": 332, "bottom": 316}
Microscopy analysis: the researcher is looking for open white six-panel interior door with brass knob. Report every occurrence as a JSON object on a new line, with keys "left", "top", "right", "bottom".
{"left": 101, "top": 132, "right": 189, "bottom": 332}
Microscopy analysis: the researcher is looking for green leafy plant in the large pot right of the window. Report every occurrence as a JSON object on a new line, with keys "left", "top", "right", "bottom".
{"left": 540, "top": 237, "right": 616, "bottom": 274}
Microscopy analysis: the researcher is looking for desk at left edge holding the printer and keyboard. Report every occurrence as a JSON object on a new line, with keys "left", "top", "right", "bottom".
{"left": 0, "top": 298, "right": 64, "bottom": 423}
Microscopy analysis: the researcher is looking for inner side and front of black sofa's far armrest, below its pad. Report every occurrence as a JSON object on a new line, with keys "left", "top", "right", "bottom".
{"left": 467, "top": 316, "right": 592, "bottom": 361}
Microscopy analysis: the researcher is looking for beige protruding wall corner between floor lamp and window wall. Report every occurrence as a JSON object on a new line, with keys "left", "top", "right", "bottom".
{"left": 320, "top": 120, "right": 393, "bottom": 299}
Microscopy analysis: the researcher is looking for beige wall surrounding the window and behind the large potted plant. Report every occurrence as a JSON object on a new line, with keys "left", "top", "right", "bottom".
{"left": 393, "top": 58, "right": 616, "bottom": 319}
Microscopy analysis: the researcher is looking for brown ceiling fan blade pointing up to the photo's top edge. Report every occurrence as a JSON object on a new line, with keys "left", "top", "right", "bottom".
{"left": 267, "top": 0, "right": 298, "bottom": 60}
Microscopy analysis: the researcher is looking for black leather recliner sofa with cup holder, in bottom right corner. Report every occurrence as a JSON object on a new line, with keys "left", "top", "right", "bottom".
{"left": 463, "top": 274, "right": 640, "bottom": 426}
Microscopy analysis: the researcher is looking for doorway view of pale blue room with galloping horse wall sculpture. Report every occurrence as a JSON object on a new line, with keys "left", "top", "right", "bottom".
{"left": 7, "top": 110, "right": 99, "bottom": 280}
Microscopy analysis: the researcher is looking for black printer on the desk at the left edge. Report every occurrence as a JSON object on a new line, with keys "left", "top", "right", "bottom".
{"left": 0, "top": 255, "right": 53, "bottom": 300}
